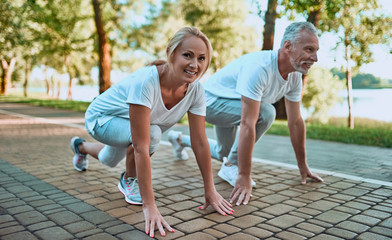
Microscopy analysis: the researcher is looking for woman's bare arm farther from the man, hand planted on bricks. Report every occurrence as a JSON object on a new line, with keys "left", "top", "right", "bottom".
{"left": 129, "top": 104, "right": 174, "bottom": 237}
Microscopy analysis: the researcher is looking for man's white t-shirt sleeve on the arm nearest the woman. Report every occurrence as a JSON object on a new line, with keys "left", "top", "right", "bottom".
{"left": 236, "top": 64, "right": 268, "bottom": 101}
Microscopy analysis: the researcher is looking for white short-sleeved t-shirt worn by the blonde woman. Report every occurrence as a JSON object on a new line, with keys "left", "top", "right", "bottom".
{"left": 85, "top": 66, "right": 206, "bottom": 132}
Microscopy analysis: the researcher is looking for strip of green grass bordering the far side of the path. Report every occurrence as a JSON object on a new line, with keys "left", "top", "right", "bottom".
{"left": 0, "top": 95, "right": 392, "bottom": 148}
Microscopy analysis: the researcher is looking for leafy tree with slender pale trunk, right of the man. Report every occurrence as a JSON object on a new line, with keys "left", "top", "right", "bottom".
{"left": 320, "top": 0, "right": 392, "bottom": 129}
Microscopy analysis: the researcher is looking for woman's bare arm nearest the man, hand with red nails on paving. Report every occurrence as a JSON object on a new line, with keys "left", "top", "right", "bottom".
{"left": 188, "top": 112, "right": 233, "bottom": 215}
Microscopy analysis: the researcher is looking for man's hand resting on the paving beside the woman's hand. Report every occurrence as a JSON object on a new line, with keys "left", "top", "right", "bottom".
{"left": 230, "top": 174, "right": 252, "bottom": 205}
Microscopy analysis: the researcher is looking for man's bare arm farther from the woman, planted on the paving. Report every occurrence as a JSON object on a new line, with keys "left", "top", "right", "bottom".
{"left": 285, "top": 99, "right": 323, "bottom": 184}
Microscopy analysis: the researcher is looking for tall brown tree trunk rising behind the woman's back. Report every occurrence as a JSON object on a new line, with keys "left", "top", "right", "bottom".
{"left": 92, "top": 0, "right": 111, "bottom": 93}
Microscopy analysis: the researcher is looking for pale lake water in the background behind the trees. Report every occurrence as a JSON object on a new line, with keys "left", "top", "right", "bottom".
{"left": 24, "top": 86, "right": 392, "bottom": 122}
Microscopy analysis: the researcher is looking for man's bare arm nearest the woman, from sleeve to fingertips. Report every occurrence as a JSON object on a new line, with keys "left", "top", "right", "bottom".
{"left": 230, "top": 96, "right": 260, "bottom": 205}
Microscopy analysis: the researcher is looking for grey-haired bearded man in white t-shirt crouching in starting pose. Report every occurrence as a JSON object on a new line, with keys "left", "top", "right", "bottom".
{"left": 169, "top": 22, "right": 323, "bottom": 205}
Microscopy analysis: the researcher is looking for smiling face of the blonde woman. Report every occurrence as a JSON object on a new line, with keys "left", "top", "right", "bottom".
{"left": 171, "top": 36, "right": 208, "bottom": 83}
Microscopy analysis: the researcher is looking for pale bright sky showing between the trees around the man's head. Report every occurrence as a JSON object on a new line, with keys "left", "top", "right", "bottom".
{"left": 246, "top": 0, "right": 392, "bottom": 79}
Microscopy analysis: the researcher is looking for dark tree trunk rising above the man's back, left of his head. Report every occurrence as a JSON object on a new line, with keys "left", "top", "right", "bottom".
{"left": 262, "top": 0, "right": 278, "bottom": 50}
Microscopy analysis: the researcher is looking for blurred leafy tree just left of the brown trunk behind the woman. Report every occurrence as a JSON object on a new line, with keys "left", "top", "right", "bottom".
{"left": 30, "top": 0, "right": 93, "bottom": 99}
